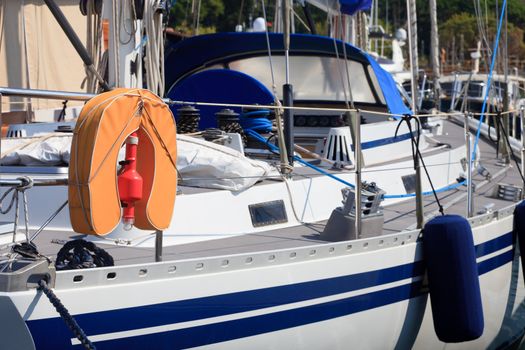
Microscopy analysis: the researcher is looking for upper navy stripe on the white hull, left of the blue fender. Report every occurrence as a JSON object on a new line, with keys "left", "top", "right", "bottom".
{"left": 28, "top": 261, "right": 424, "bottom": 334}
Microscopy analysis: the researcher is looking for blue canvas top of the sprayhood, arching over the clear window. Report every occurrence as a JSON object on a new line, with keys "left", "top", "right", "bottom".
{"left": 165, "top": 33, "right": 411, "bottom": 115}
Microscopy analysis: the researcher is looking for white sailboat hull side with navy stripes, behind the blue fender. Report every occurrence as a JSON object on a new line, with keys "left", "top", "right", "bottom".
{"left": 0, "top": 210, "right": 525, "bottom": 349}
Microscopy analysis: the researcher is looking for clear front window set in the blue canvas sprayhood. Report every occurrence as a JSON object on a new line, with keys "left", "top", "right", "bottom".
{"left": 229, "top": 56, "right": 376, "bottom": 104}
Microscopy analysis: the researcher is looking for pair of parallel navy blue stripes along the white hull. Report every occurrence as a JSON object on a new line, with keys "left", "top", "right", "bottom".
{"left": 27, "top": 233, "right": 514, "bottom": 349}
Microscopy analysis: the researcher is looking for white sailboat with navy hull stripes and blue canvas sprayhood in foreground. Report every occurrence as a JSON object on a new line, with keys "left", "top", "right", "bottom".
{"left": 0, "top": 0, "right": 525, "bottom": 349}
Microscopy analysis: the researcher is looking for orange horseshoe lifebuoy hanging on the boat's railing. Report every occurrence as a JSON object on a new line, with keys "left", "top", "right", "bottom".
{"left": 68, "top": 89, "right": 177, "bottom": 235}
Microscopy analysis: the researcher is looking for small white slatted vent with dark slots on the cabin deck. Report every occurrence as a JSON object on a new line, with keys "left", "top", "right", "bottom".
{"left": 323, "top": 126, "right": 353, "bottom": 166}
